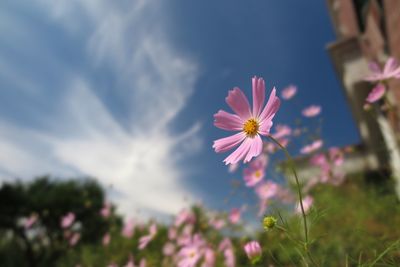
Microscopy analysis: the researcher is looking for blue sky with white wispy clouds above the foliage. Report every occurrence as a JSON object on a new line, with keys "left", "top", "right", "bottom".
{"left": 0, "top": 0, "right": 359, "bottom": 220}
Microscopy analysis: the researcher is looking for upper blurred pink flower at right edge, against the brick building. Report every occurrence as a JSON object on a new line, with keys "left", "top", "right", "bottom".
{"left": 364, "top": 57, "right": 400, "bottom": 82}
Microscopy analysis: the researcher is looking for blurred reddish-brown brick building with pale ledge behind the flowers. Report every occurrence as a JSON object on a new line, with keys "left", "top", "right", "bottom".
{"left": 327, "top": 0, "right": 400, "bottom": 196}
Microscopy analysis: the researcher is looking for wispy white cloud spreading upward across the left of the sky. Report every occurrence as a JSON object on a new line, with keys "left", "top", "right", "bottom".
{"left": 0, "top": 0, "right": 201, "bottom": 220}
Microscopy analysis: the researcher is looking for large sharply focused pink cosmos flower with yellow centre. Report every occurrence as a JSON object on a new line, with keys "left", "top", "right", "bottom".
{"left": 213, "top": 77, "right": 280, "bottom": 164}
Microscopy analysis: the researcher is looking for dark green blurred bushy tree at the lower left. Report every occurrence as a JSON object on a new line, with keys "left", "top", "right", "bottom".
{"left": 0, "top": 177, "right": 114, "bottom": 266}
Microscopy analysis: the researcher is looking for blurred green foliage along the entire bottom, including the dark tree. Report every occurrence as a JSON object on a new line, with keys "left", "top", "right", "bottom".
{"left": 0, "top": 177, "right": 400, "bottom": 267}
